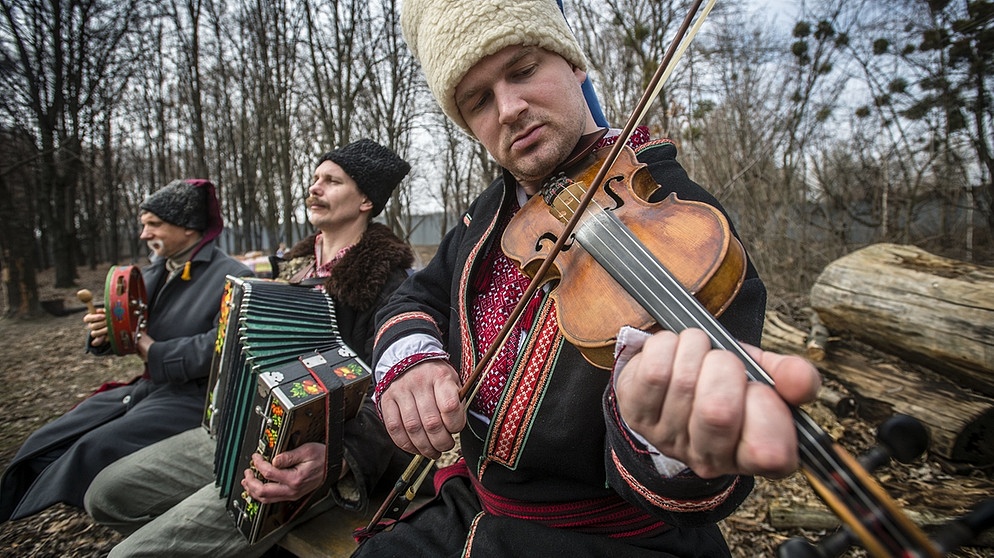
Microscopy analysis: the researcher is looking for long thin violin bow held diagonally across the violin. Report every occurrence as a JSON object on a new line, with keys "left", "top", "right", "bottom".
{"left": 354, "top": 0, "right": 716, "bottom": 541}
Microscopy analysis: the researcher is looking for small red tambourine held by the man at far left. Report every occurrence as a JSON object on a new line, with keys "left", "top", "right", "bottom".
{"left": 104, "top": 265, "right": 148, "bottom": 355}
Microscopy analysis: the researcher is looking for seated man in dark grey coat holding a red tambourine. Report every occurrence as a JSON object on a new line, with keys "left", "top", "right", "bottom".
{"left": 0, "top": 179, "right": 252, "bottom": 522}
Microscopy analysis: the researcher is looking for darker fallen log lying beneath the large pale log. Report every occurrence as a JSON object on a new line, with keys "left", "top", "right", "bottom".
{"left": 763, "top": 312, "right": 994, "bottom": 467}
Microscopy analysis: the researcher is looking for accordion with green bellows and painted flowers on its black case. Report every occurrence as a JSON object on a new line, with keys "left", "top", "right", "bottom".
{"left": 203, "top": 276, "right": 371, "bottom": 543}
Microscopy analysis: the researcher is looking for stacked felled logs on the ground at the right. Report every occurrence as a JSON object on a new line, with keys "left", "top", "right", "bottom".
{"left": 764, "top": 244, "right": 994, "bottom": 470}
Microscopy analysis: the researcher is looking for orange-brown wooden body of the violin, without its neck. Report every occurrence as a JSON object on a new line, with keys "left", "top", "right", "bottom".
{"left": 501, "top": 140, "right": 746, "bottom": 369}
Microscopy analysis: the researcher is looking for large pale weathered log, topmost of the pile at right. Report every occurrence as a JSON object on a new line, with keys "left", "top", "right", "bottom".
{"left": 811, "top": 244, "right": 994, "bottom": 396}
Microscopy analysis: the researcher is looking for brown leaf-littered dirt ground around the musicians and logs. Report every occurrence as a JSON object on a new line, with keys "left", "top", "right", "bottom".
{"left": 0, "top": 268, "right": 994, "bottom": 558}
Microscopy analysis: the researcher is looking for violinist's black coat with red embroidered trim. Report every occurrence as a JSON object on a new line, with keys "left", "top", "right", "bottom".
{"left": 357, "top": 141, "right": 766, "bottom": 558}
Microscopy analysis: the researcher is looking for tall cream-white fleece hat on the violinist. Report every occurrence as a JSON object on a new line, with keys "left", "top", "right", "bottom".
{"left": 400, "top": 0, "right": 587, "bottom": 135}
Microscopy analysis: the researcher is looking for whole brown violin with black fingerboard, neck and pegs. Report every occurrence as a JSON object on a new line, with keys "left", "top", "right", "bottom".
{"left": 501, "top": 133, "right": 994, "bottom": 558}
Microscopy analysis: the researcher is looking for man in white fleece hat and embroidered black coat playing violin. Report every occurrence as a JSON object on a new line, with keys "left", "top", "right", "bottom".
{"left": 356, "top": 0, "right": 819, "bottom": 557}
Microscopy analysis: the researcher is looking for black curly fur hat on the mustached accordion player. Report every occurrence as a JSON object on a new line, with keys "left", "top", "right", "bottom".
{"left": 318, "top": 139, "right": 411, "bottom": 217}
